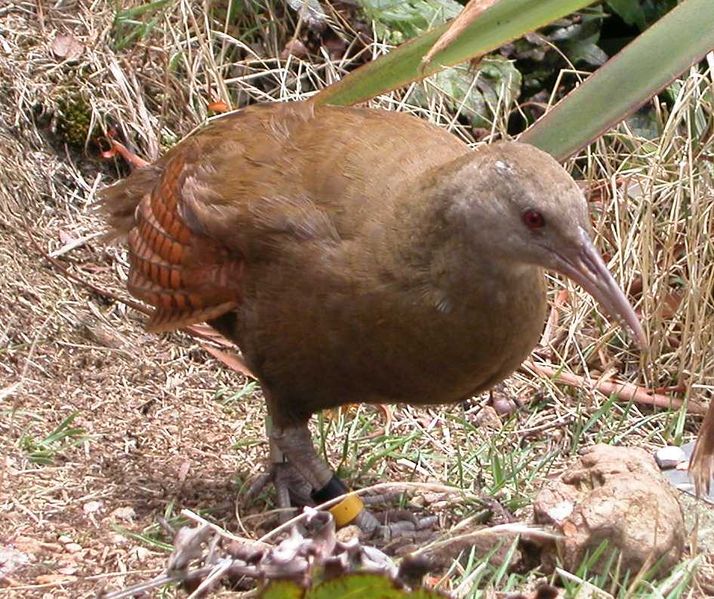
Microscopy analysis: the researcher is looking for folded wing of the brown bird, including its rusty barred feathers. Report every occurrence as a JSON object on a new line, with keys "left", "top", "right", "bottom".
{"left": 102, "top": 106, "right": 336, "bottom": 331}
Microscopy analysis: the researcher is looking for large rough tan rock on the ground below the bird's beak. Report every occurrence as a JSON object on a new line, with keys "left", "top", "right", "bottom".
{"left": 534, "top": 445, "right": 685, "bottom": 574}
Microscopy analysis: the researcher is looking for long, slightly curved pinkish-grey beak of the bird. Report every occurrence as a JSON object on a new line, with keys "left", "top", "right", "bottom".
{"left": 556, "top": 228, "right": 647, "bottom": 349}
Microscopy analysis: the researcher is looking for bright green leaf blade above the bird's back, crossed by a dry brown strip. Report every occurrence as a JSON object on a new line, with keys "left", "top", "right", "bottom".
{"left": 313, "top": 0, "right": 594, "bottom": 105}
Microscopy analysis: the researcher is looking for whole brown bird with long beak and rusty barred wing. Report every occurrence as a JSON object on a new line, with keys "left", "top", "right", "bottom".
{"left": 103, "top": 103, "right": 644, "bottom": 534}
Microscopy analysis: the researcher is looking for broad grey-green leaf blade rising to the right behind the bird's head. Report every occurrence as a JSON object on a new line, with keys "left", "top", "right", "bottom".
{"left": 520, "top": 0, "right": 714, "bottom": 160}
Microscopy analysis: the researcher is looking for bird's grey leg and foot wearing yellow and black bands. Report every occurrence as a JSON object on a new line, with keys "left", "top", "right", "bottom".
{"left": 269, "top": 423, "right": 434, "bottom": 539}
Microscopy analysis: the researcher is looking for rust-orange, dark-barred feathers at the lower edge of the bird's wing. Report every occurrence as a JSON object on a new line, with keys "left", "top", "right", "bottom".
{"left": 108, "top": 154, "right": 244, "bottom": 331}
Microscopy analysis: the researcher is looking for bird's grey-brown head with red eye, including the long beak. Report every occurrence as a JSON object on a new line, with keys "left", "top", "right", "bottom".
{"left": 442, "top": 142, "right": 645, "bottom": 347}
